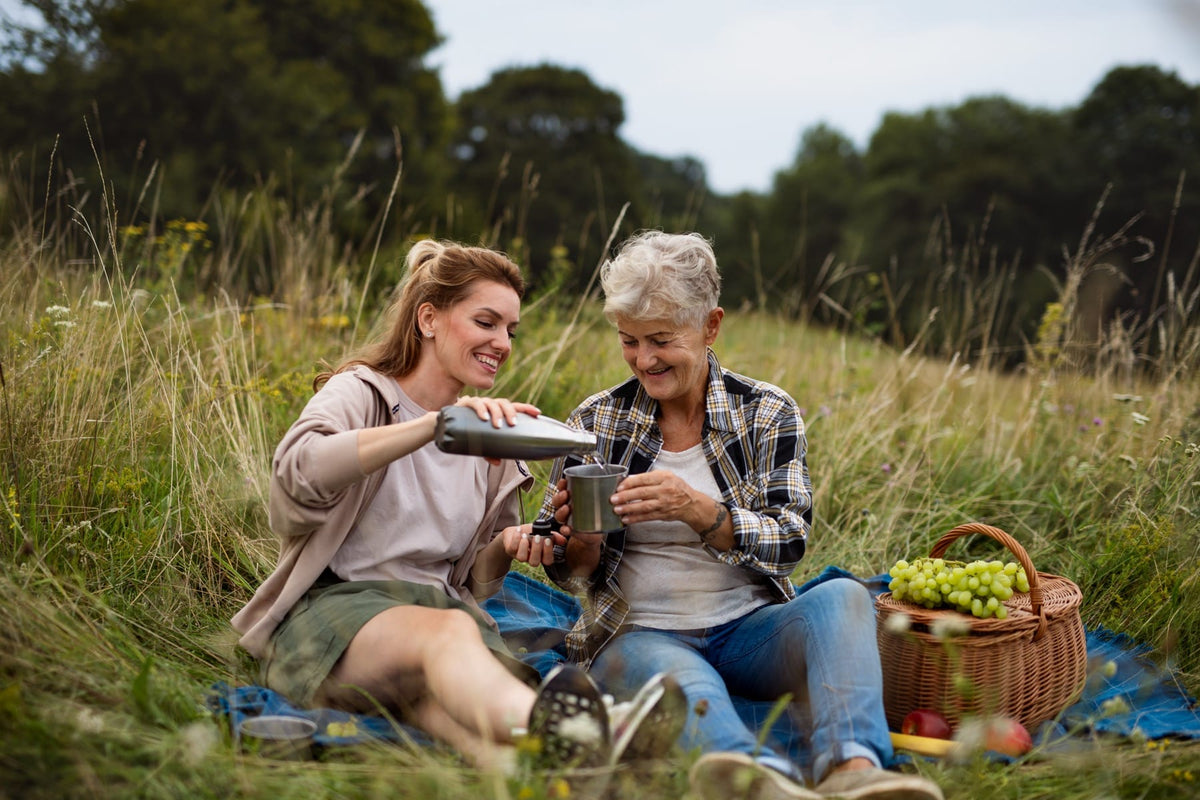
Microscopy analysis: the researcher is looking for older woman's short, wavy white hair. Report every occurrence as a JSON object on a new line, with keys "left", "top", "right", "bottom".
{"left": 600, "top": 230, "right": 721, "bottom": 327}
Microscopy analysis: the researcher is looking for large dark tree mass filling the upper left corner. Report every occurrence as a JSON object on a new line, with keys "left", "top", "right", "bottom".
{"left": 0, "top": 0, "right": 450, "bottom": 241}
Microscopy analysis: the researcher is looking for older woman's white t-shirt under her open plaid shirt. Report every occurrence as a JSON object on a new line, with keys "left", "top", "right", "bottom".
{"left": 617, "top": 445, "right": 773, "bottom": 631}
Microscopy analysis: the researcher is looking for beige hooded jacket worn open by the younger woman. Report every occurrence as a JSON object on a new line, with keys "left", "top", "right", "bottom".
{"left": 232, "top": 366, "right": 534, "bottom": 657}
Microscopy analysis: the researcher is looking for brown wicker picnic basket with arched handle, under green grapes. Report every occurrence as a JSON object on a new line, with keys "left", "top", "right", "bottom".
{"left": 875, "top": 523, "right": 1087, "bottom": 733}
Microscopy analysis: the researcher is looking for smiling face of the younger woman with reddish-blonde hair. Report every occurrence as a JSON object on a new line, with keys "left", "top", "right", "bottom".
{"left": 418, "top": 281, "right": 521, "bottom": 389}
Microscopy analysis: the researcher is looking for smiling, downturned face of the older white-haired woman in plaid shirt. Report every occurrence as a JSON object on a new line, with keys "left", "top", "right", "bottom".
{"left": 614, "top": 308, "right": 725, "bottom": 407}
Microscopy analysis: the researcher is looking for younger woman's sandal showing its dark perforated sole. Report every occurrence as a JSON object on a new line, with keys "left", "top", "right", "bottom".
{"left": 528, "top": 664, "right": 612, "bottom": 770}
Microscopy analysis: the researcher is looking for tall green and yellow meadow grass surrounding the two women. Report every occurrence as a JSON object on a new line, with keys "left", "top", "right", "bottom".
{"left": 0, "top": 165, "right": 1200, "bottom": 799}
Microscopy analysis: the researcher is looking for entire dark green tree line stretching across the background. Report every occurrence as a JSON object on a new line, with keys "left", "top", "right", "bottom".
{"left": 0, "top": 0, "right": 1200, "bottom": 363}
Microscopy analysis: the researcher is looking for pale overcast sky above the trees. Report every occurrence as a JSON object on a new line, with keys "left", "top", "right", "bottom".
{"left": 426, "top": 0, "right": 1200, "bottom": 193}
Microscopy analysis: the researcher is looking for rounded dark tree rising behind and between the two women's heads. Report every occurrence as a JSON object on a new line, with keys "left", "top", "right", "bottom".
{"left": 451, "top": 64, "right": 646, "bottom": 289}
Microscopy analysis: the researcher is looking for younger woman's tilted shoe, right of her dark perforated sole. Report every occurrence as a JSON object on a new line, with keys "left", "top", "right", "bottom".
{"left": 611, "top": 672, "right": 688, "bottom": 764}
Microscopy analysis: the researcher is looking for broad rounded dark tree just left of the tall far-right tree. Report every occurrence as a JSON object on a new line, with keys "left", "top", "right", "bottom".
{"left": 848, "top": 97, "right": 1087, "bottom": 351}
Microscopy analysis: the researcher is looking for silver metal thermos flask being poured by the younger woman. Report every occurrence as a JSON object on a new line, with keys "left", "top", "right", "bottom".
{"left": 433, "top": 405, "right": 596, "bottom": 461}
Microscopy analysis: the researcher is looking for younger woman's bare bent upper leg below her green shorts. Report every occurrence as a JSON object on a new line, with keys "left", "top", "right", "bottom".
{"left": 317, "top": 606, "right": 536, "bottom": 752}
